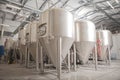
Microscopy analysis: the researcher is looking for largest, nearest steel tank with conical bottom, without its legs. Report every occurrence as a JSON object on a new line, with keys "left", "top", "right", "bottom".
{"left": 38, "top": 8, "right": 74, "bottom": 66}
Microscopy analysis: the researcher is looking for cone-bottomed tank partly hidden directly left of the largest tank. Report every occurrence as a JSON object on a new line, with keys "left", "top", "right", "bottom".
{"left": 26, "top": 21, "right": 37, "bottom": 60}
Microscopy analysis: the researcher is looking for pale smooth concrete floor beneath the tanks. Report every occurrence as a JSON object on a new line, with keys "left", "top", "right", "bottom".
{"left": 0, "top": 60, "right": 120, "bottom": 80}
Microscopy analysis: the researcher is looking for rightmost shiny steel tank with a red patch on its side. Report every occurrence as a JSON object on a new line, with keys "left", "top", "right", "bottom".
{"left": 97, "top": 30, "right": 113, "bottom": 60}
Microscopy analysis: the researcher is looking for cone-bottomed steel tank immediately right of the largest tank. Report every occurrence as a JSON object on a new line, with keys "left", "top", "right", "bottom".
{"left": 75, "top": 20, "right": 96, "bottom": 64}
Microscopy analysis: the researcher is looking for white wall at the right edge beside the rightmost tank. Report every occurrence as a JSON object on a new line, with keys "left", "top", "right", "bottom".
{"left": 111, "top": 34, "right": 120, "bottom": 59}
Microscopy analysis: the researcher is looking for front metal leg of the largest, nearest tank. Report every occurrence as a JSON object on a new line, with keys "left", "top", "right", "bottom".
{"left": 57, "top": 37, "right": 62, "bottom": 80}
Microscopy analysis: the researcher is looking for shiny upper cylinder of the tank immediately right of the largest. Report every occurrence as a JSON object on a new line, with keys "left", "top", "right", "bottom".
{"left": 75, "top": 20, "right": 96, "bottom": 42}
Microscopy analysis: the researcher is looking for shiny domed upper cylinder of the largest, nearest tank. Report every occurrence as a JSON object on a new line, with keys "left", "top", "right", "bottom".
{"left": 40, "top": 8, "right": 74, "bottom": 37}
